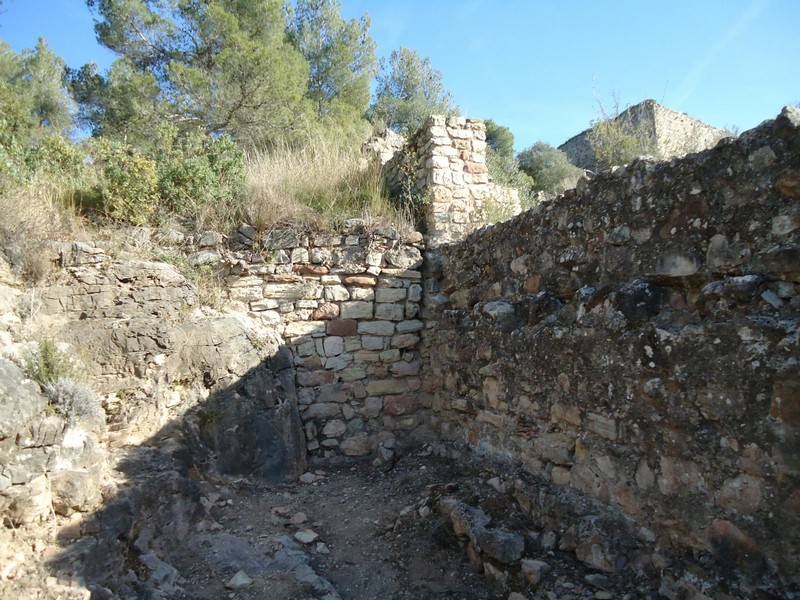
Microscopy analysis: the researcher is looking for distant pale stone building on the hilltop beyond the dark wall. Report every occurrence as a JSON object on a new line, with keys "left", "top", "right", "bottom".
{"left": 558, "top": 100, "right": 731, "bottom": 171}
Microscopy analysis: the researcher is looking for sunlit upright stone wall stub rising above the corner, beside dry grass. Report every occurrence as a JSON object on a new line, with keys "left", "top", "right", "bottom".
{"left": 386, "top": 116, "right": 521, "bottom": 248}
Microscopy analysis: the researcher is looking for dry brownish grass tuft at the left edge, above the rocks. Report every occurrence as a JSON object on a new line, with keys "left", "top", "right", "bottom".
{"left": 0, "top": 175, "right": 85, "bottom": 283}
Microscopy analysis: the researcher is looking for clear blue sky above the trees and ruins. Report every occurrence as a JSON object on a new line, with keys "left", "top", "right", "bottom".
{"left": 0, "top": 0, "right": 800, "bottom": 150}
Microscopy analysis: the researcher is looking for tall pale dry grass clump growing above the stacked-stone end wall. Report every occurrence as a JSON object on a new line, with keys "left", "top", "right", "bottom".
{"left": 242, "top": 136, "right": 397, "bottom": 231}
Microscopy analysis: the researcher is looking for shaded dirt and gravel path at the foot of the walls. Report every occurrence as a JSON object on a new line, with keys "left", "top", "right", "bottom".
{"left": 166, "top": 457, "right": 507, "bottom": 600}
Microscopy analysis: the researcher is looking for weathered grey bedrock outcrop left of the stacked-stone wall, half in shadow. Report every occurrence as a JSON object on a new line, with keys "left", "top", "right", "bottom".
{"left": 28, "top": 251, "right": 306, "bottom": 480}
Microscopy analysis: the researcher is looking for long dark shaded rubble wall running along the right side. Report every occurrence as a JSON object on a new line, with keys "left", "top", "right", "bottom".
{"left": 423, "top": 109, "right": 800, "bottom": 589}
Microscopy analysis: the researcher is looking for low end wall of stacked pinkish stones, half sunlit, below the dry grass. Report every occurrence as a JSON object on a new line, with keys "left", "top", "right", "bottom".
{"left": 203, "top": 220, "right": 426, "bottom": 457}
